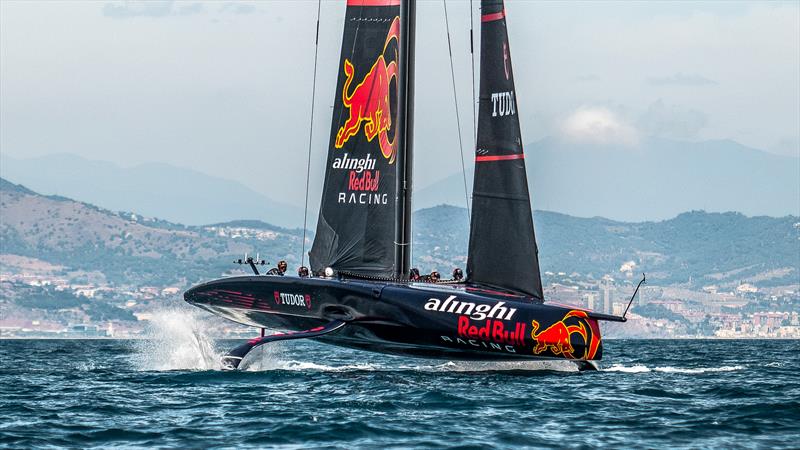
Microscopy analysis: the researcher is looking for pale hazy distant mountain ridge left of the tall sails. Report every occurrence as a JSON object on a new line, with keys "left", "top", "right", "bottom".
{"left": 0, "top": 153, "right": 303, "bottom": 227}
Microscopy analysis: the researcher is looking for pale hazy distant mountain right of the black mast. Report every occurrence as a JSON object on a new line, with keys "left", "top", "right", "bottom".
{"left": 414, "top": 138, "right": 800, "bottom": 222}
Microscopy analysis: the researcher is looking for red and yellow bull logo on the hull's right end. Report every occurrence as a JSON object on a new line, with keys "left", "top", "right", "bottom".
{"left": 531, "top": 310, "right": 600, "bottom": 359}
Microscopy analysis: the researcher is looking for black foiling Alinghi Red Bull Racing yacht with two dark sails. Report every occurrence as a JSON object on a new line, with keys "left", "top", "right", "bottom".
{"left": 184, "top": 0, "right": 638, "bottom": 370}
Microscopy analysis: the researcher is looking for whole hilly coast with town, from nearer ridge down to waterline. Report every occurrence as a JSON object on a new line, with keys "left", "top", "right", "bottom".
{"left": 0, "top": 178, "right": 800, "bottom": 339}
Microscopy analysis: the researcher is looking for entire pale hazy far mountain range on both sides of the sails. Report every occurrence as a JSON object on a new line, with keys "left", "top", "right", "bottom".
{"left": 0, "top": 138, "right": 800, "bottom": 228}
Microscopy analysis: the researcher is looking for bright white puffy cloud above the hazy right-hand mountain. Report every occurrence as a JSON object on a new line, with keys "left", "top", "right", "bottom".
{"left": 561, "top": 106, "right": 639, "bottom": 146}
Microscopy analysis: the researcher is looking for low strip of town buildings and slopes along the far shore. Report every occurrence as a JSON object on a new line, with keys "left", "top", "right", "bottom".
{"left": 0, "top": 262, "right": 800, "bottom": 339}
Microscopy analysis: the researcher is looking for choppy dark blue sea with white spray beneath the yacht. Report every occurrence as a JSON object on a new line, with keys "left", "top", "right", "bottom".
{"left": 0, "top": 317, "right": 800, "bottom": 448}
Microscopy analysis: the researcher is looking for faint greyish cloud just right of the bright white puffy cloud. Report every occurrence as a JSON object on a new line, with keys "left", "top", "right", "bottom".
{"left": 636, "top": 99, "right": 708, "bottom": 139}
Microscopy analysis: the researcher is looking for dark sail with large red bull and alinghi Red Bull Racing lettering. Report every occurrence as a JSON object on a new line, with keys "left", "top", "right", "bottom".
{"left": 309, "top": 0, "right": 400, "bottom": 276}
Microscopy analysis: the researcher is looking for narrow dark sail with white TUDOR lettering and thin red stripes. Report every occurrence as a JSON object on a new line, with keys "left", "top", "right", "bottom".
{"left": 467, "top": 0, "right": 544, "bottom": 299}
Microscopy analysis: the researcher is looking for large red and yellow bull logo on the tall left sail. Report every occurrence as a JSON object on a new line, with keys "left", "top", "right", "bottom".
{"left": 335, "top": 17, "right": 400, "bottom": 164}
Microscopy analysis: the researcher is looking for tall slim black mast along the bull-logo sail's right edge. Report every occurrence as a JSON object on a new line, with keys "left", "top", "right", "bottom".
{"left": 394, "top": 0, "right": 416, "bottom": 278}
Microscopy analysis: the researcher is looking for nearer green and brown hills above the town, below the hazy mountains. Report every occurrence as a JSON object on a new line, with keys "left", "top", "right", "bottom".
{"left": 0, "top": 179, "right": 800, "bottom": 287}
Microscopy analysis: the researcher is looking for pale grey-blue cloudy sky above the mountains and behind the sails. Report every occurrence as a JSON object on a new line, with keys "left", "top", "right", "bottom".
{"left": 0, "top": 0, "right": 800, "bottom": 207}
